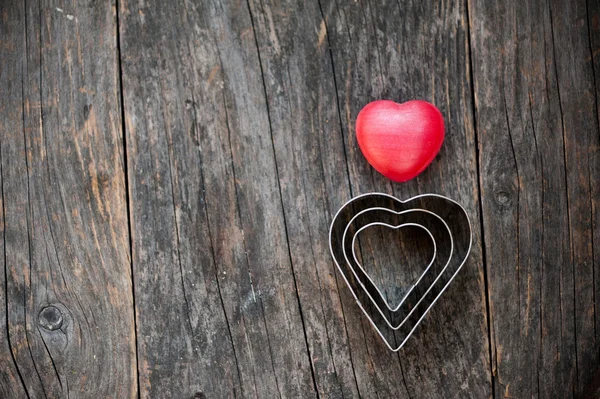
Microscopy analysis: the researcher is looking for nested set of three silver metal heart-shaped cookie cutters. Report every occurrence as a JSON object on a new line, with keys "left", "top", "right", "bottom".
{"left": 329, "top": 193, "right": 472, "bottom": 352}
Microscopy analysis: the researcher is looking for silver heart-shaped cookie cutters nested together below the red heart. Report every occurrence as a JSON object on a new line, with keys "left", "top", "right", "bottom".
{"left": 329, "top": 193, "right": 472, "bottom": 351}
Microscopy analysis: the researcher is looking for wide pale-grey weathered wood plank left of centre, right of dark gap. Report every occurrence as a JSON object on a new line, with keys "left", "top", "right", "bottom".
{"left": 121, "top": 1, "right": 315, "bottom": 397}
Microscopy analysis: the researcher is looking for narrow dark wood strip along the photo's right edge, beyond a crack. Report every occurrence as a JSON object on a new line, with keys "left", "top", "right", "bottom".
{"left": 550, "top": 1, "right": 600, "bottom": 392}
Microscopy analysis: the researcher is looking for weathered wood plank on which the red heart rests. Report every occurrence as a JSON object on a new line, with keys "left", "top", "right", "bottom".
{"left": 322, "top": 1, "right": 491, "bottom": 397}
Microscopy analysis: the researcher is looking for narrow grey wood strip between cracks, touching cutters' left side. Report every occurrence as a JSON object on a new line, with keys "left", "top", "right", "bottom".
{"left": 243, "top": 1, "right": 370, "bottom": 397}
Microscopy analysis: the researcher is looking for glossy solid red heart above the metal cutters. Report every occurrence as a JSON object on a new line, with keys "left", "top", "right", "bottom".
{"left": 356, "top": 100, "right": 444, "bottom": 182}
